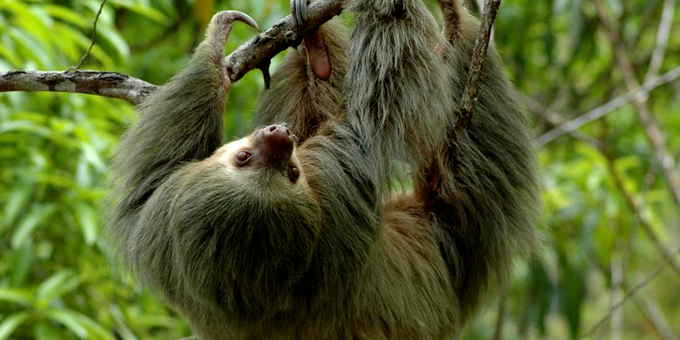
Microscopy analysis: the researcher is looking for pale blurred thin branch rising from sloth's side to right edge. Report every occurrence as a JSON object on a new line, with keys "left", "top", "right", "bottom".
{"left": 532, "top": 66, "right": 680, "bottom": 148}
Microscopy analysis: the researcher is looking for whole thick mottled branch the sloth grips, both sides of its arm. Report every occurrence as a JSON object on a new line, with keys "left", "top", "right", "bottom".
{"left": 0, "top": 0, "right": 343, "bottom": 104}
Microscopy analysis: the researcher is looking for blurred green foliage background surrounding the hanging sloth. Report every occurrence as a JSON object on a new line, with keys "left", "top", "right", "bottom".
{"left": 0, "top": 0, "right": 680, "bottom": 340}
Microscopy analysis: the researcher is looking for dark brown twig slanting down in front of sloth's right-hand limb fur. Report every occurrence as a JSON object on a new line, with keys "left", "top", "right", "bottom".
{"left": 456, "top": 0, "right": 501, "bottom": 132}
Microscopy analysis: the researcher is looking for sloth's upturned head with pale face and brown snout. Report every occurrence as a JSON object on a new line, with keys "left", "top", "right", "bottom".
{"left": 172, "top": 125, "right": 321, "bottom": 303}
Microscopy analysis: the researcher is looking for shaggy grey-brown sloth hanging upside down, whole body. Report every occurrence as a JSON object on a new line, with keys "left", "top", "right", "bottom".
{"left": 110, "top": 0, "right": 539, "bottom": 340}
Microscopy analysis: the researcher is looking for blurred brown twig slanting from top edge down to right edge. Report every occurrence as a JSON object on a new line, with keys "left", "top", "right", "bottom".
{"left": 593, "top": 0, "right": 680, "bottom": 208}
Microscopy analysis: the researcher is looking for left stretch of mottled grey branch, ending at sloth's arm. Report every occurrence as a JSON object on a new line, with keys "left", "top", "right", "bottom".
{"left": 0, "top": 71, "right": 157, "bottom": 104}
